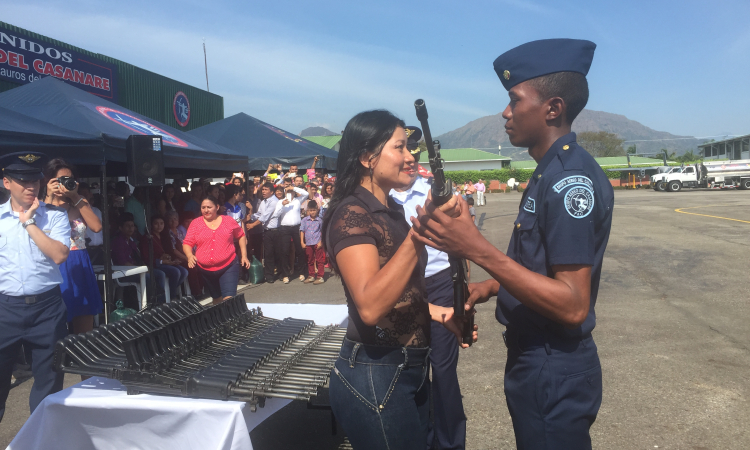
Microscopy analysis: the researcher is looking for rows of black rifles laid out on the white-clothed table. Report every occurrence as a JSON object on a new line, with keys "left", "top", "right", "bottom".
{"left": 54, "top": 294, "right": 346, "bottom": 411}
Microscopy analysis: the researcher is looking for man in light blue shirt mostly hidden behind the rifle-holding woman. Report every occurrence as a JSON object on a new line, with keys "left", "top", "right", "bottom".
{"left": 390, "top": 127, "right": 466, "bottom": 449}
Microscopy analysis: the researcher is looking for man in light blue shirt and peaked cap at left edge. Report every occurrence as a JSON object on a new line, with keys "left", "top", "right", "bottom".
{"left": 0, "top": 152, "right": 70, "bottom": 420}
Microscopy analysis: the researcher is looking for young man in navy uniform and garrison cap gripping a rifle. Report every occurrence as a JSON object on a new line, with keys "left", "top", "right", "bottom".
{"left": 414, "top": 39, "right": 614, "bottom": 449}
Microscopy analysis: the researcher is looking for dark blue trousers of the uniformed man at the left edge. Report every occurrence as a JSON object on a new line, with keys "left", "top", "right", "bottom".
{"left": 0, "top": 287, "right": 68, "bottom": 421}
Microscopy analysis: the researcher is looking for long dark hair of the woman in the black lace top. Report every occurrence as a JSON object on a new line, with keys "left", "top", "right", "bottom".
{"left": 322, "top": 109, "right": 406, "bottom": 271}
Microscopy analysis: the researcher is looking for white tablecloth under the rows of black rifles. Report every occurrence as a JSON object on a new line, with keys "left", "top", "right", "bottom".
{"left": 8, "top": 303, "right": 348, "bottom": 450}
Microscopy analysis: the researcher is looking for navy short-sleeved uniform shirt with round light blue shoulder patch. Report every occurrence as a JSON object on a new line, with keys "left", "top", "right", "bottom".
{"left": 495, "top": 133, "right": 614, "bottom": 337}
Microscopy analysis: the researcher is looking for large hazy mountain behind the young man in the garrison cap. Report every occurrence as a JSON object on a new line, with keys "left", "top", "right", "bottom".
{"left": 436, "top": 109, "right": 705, "bottom": 160}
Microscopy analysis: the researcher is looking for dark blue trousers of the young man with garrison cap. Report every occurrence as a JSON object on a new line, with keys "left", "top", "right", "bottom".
{"left": 505, "top": 328, "right": 602, "bottom": 450}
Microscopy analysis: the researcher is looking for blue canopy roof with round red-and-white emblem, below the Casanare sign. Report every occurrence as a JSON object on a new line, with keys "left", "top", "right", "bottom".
{"left": 0, "top": 77, "right": 247, "bottom": 176}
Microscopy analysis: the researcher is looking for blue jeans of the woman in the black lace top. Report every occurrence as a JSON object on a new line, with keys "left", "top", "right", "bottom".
{"left": 330, "top": 339, "right": 430, "bottom": 450}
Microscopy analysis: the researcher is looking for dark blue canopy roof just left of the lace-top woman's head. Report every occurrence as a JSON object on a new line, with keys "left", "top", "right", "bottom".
{"left": 188, "top": 113, "right": 338, "bottom": 171}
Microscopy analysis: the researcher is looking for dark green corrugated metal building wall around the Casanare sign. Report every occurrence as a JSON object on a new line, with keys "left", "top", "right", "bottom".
{"left": 0, "top": 21, "right": 224, "bottom": 131}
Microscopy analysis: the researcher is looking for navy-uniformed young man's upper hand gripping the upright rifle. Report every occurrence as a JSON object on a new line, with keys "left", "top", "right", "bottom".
{"left": 411, "top": 195, "right": 492, "bottom": 260}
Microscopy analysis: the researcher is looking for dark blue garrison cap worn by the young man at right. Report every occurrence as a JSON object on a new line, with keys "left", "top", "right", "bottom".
{"left": 493, "top": 39, "right": 596, "bottom": 91}
